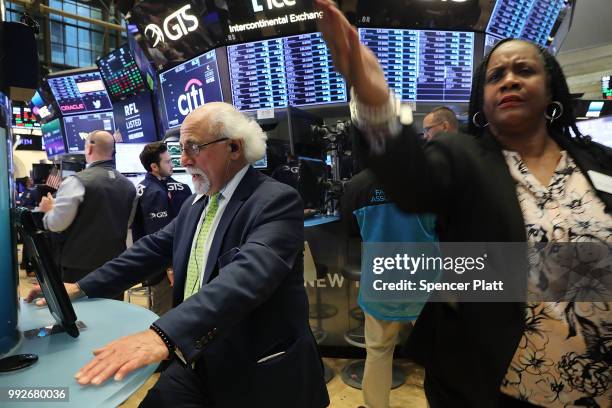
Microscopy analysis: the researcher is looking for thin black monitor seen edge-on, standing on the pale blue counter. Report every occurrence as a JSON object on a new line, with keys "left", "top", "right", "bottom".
{"left": 15, "top": 207, "right": 79, "bottom": 337}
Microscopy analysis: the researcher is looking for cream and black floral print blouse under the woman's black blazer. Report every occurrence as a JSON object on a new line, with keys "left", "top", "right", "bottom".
{"left": 501, "top": 151, "right": 612, "bottom": 407}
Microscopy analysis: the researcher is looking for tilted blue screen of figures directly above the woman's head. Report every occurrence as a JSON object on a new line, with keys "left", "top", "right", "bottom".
{"left": 486, "top": 0, "right": 564, "bottom": 45}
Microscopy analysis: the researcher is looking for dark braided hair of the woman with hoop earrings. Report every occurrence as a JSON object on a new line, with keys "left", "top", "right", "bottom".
{"left": 468, "top": 38, "right": 583, "bottom": 139}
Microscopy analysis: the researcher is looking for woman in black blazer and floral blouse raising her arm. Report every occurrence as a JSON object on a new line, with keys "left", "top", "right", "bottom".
{"left": 316, "top": 0, "right": 612, "bottom": 408}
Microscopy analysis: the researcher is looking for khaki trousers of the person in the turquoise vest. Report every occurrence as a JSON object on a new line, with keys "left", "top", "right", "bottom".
{"left": 362, "top": 313, "right": 403, "bottom": 408}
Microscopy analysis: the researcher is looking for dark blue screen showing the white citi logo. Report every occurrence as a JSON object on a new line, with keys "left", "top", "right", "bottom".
{"left": 159, "top": 50, "right": 223, "bottom": 128}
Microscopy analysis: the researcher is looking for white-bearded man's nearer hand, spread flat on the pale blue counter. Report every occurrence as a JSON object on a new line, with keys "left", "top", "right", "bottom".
{"left": 74, "top": 329, "right": 169, "bottom": 385}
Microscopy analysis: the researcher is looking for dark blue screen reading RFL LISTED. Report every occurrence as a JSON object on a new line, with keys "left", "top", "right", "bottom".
{"left": 113, "top": 92, "right": 157, "bottom": 143}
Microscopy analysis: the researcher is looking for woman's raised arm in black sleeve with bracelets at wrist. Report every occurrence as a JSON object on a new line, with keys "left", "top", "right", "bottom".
{"left": 315, "top": 0, "right": 458, "bottom": 213}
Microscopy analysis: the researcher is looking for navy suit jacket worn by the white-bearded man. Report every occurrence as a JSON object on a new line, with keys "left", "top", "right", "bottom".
{"left": 79, "top": 167, "right": 329, "bottom": 408}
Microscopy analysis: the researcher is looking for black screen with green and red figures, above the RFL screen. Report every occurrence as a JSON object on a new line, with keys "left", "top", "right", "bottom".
{"left": 96, "top": 44, "right": 146, "bottom": 101}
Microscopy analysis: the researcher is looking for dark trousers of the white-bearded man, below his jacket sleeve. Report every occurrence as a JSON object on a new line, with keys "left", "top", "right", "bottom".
{"left": 139, "top": 360, "right": 214, "bottom": 408}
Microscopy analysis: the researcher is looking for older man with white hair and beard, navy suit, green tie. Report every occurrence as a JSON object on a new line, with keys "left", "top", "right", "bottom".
{"left": 29, "top": 103, "right": 329, "bottom": 408}
